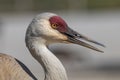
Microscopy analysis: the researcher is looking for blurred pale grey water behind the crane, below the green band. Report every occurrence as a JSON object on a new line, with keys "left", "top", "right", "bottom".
{"left": 0, "top": 11, "right": 120, "bottom": 80}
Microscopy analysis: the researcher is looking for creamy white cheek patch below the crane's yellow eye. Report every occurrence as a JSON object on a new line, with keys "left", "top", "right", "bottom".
{"left": 36, "top": 19, "right": 66, "bottom": 40}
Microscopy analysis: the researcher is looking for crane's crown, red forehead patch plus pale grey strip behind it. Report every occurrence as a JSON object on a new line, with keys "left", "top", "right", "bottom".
{"left": 34, "top": 12, "right": 67, "bottom": 32}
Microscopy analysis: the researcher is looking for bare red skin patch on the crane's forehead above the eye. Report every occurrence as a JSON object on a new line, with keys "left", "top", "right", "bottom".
{"left": 49, "top": 16, "right": 67, "bottom": 32}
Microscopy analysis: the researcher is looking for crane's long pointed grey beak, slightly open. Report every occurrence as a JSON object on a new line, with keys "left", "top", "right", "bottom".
{"left": 64, "top": 28, "right": 105, "bottom": 53}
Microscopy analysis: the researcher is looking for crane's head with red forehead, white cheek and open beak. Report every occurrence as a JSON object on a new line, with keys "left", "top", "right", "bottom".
{"left": 28, "top": 13, "right": 105, "bottom": 52}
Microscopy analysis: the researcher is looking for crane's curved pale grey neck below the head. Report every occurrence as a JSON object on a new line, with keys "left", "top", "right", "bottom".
{"left": 27, "top": 38, "right": 67, "bottom": 80}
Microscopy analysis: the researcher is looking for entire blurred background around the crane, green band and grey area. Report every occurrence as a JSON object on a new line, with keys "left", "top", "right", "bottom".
{"left": 0, "top": 0, "right": 120, "bottom": 80}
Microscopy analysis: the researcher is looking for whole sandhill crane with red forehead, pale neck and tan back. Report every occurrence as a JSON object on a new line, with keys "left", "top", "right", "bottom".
{"left": 0, "top": 13, "right": 104, "bottom": 80}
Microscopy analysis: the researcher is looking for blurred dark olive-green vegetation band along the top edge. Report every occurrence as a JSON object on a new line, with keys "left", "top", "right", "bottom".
{"left": 0, "top": 0, "right": 120, "bottom": 12}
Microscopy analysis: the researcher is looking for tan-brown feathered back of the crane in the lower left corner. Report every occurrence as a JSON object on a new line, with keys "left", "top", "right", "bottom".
{"left": 0, "top": 53, "right": 35, "bottom": 80}
